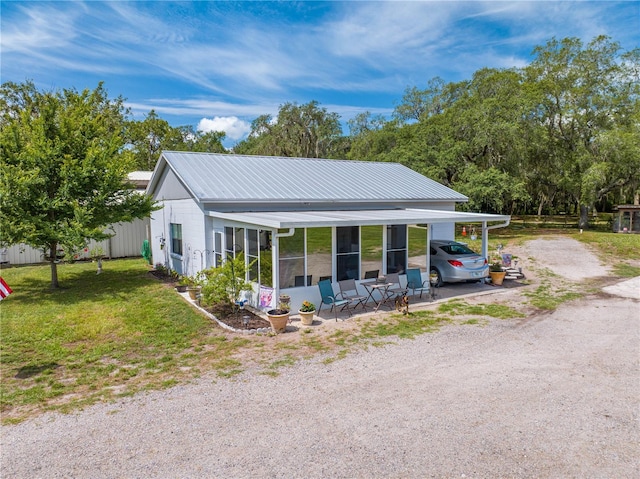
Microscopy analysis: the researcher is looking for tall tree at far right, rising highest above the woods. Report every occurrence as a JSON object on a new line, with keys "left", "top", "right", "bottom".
{"left": 525, "top": 36, "right": 640, "bottom": 228}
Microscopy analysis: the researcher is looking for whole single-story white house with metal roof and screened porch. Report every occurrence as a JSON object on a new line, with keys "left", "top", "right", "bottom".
{"left": 147, "top": 151, "right": 510, "bottom": 310}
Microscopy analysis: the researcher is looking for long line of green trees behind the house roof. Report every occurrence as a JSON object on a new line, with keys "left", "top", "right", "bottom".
{"left": 5, "top": 36, "right": 640, "bottom": 227}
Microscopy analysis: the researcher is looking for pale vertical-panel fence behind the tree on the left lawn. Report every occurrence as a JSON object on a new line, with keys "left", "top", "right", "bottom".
{"left": 0, "top": 218, "right": 149, "bottom": 264}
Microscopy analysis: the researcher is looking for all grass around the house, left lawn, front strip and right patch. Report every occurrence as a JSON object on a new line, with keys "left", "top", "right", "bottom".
{"left": 0, "top": 228, "right": 640, "bottom": 424}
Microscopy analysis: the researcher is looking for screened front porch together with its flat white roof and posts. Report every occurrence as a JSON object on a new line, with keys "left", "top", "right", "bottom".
{"left": 209, "top": 209, "right": 509, "bottom": 308}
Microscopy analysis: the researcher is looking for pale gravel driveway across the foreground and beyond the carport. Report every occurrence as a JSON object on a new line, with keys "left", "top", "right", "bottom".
{"left": 0, "top": 239, "right": 640, "bottom": 478}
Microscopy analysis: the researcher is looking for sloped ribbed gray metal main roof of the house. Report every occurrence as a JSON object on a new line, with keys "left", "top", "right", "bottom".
{"left": 152, "top": 151, "right": 467, "bottom": 203}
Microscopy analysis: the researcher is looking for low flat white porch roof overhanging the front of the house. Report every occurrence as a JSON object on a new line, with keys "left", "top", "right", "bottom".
{"left": 207, "top": 208, "right": 511, "bottom": 229}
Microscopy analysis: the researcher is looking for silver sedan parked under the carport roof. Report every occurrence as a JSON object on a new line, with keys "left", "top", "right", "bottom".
{"left": 430, "top": 240, "right": 489, "bottom": 286}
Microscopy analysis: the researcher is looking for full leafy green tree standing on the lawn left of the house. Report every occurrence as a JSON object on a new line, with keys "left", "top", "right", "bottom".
{"left": 0, "top": 82, "right": 153, "bottom": 288}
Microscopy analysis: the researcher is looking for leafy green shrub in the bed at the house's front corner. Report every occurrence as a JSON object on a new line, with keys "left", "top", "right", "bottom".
{"left": 201, "top": 254, "right": 253, "bottom": 306}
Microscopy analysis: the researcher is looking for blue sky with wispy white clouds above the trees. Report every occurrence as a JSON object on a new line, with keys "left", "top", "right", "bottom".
{"left": 0, "top": 1, "right": 640, "bottom": 146}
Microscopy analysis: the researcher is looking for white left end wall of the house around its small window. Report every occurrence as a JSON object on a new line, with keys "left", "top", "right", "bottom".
{"left": 151, "top": 199, "right": 207, "bottom": 275}
